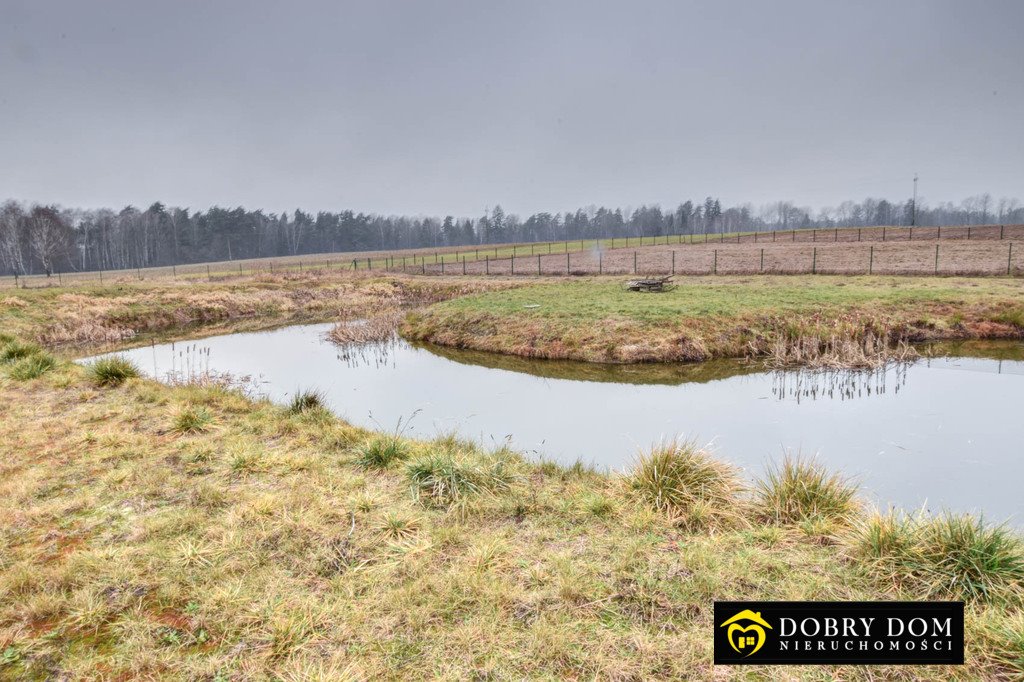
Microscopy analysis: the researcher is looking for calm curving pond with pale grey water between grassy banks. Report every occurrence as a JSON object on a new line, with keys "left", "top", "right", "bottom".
{"left": 86, "top": 324, "right": 1024, "bottom": 525}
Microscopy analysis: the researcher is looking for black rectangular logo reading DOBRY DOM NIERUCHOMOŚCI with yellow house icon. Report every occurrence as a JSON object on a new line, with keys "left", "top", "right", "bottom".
{"left": 715, "top": 601, "right": 964, "bottom": 666}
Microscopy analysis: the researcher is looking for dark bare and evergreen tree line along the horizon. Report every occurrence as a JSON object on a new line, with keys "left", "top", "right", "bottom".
{"left": 0, "top": 194, "right": 1024, "bottom": 274}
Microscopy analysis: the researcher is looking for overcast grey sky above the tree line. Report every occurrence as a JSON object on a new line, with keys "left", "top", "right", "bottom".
{"left": 0, "top": 0, "right": 1024, "bottom": 215}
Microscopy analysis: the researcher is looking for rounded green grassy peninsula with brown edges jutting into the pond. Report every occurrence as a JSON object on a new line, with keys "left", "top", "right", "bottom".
{"left": 403, "top": 276, "right": 1024, "bottom": 363}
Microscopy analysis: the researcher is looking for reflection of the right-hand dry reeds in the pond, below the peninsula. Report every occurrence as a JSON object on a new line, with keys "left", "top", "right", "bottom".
{"left": 771, "top": 363, "right": 912, "bottom": 402}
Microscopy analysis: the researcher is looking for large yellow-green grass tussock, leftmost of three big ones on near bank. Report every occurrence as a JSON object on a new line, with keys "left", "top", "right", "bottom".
{"left": 627, "top": 441, "right": 746, "bottom": 530}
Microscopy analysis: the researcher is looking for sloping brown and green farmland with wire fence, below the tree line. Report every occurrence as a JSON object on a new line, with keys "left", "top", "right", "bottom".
{"left": 0, "top": 225, "right": 1024, "bottom": 288}
